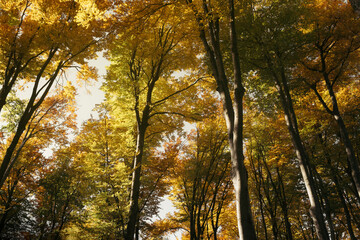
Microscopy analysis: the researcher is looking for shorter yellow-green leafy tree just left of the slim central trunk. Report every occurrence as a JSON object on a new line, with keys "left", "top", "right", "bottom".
{"left": 63, "top": 107, "right": 130, "bottom": 239}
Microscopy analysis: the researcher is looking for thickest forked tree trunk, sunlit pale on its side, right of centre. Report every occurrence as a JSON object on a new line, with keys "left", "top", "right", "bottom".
{"left": 186, "top": 0, "right": 256, "bottom": 236}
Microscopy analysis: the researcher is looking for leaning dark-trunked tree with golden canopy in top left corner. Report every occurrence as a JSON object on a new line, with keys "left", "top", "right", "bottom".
{"left": 0, "top": 0, "right": 112, "bottom": 186}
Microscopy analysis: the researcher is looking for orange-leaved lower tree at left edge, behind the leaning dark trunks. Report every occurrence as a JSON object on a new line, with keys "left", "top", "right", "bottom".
{"left": 0, "top": 85, "right": 75, "bottom": 237}
